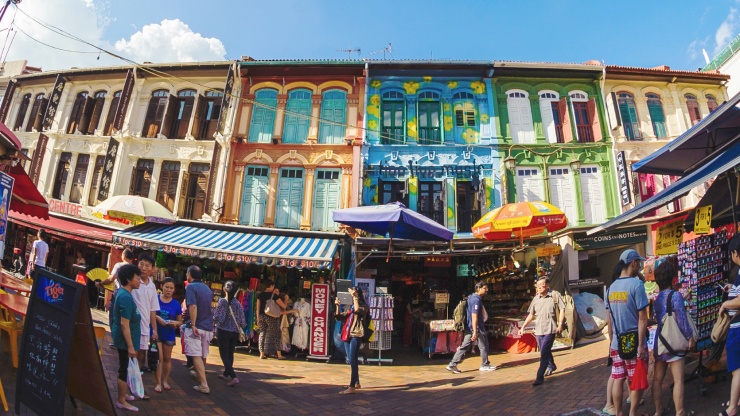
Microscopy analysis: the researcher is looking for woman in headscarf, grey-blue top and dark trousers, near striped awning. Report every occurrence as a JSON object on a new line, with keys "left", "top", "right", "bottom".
{"left": 214, "top": 280, "right": 247, "bottom": 387}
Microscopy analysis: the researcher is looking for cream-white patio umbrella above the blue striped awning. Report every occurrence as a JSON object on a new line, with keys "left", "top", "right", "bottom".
{"left": 92, "top": 195, "right": 177, "bottom": 225}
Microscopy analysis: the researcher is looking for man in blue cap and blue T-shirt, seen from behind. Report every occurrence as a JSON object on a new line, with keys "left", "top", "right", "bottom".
{"left": 606, "top": 249, "right": 648, "bottom": 415}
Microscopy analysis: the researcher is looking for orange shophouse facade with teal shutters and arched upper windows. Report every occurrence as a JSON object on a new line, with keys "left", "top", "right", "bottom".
{"left": 221, "top": 60, "right": 365, "bottom": 232}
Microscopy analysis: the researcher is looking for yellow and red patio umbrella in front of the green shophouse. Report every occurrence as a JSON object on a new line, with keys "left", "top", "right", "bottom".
{"left": 473, "top": 201, "right": 568, "bottom": 240}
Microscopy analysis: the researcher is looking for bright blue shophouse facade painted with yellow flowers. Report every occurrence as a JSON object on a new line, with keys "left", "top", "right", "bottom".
{"left": 361, "top": 61, "right": 502, "bottom": 236}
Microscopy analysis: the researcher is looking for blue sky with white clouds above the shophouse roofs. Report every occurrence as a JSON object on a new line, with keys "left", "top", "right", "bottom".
{"left": 0, "top": 0, "right": 740, "bottom": 70}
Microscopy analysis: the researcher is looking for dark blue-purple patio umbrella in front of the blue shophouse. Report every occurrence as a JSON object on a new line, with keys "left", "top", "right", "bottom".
{"left": 332, "top": 202, "right": 454, "bottom": 261}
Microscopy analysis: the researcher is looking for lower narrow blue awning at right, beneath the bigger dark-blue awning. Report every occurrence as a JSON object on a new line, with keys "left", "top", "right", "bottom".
{"left": 587, "top": 142, "right": 740, "bottom": 235}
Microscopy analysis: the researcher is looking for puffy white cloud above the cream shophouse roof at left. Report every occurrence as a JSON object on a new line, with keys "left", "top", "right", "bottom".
{"left": 115, "top": 19, "right": 226, "bottom": 62}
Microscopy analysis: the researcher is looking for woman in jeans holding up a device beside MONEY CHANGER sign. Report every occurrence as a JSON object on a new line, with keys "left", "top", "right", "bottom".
{"left": 334, "top": 287, "right": 369, "bottom": 394}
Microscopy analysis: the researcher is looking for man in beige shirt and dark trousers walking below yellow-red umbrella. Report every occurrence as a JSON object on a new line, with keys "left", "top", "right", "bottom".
{"left": 519, "top": 277, "right": 565, "bottom": 386}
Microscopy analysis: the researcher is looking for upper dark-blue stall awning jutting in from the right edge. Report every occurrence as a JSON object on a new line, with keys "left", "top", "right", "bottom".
{"left": 632, "top": 94, "right": 740, "bottom": 176}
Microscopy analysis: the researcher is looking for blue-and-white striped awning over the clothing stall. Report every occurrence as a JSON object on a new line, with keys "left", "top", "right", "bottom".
{"left": 113, "top": 222, "right": 339, "bottom": 269}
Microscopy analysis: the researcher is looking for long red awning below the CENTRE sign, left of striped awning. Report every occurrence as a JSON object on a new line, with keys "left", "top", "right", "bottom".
{"left": 8, "top": 210, "right": 114, "bottom": 246}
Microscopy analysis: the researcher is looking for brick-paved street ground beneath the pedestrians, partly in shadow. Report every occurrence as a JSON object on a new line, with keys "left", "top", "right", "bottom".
{"left": 0, "top": 311, "right": 729, "bottom": 416}
